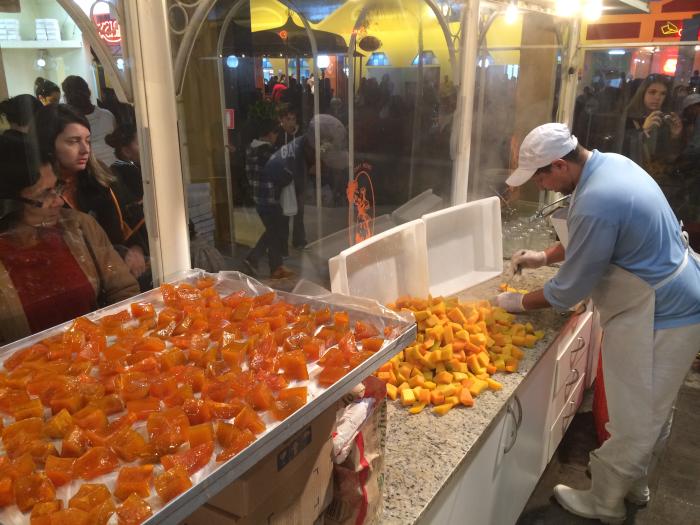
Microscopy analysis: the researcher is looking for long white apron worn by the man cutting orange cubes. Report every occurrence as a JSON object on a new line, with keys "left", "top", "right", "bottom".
{"left": 591, "top": 233, "right": 700, "bottom": 480}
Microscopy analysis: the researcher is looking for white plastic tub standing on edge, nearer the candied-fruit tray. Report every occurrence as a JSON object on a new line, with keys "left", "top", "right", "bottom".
{"left": 328, "top": 219, "right": 428, "bottom": 304}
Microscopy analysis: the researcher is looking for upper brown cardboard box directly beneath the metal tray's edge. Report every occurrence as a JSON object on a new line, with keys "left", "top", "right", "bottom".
{"left": 208, "top": 404, "right": 337, "bottom": 517}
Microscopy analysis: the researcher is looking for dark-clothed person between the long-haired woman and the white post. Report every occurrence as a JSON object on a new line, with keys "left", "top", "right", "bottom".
{"left": 105, "top": 124, "right": 153, "bottom": 291}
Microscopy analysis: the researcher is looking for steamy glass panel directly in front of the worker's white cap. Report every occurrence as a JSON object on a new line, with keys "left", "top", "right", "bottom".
{"left": 468, "top": 8, "right": 568, "bottom": 256}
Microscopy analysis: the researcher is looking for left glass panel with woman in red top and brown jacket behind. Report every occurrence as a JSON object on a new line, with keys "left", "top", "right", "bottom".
{"left": 0, "top": 0, "right": 152, "bottom": 345}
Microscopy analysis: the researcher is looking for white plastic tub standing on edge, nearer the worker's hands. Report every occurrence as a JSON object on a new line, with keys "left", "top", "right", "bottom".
{"left": 422, "top": 197, "right": 503, "bottom": 295}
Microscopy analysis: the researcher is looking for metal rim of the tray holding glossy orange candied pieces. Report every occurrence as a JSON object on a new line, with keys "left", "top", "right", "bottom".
{"left": 0, "top": 270, "right": 416, "bottom": 525}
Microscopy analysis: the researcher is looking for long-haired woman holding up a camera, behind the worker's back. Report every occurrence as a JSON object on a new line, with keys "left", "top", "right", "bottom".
{"left": 616, "top": 75, "right": 683, "bottom": 180}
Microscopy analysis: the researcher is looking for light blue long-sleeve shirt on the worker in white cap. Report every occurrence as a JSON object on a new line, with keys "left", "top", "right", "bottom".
{"left": 544, "top": 150, "right": 700, "bottom": 329}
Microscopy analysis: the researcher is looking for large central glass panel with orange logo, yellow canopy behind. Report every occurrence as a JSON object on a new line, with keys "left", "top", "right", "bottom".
{"left": 171, "top": 0, "right": 460, "bottom": 288}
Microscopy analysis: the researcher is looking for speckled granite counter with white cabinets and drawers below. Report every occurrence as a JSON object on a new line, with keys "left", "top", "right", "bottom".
{"left": 382, "top": 267, "right": 593, "bottom": 524}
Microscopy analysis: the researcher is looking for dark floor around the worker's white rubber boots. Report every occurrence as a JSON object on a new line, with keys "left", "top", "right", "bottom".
{"left": 518, "top": 372, "right": 700, "bottom": 525}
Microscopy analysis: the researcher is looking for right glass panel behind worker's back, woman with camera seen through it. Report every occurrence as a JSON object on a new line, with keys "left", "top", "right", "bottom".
{"left": 573, "top": 44, "right": 700, "bottom": 242}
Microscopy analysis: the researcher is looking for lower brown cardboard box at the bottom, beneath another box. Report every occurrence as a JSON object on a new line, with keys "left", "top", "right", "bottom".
{"left": 182, "top": 439, "right": 333, "bottom": 525}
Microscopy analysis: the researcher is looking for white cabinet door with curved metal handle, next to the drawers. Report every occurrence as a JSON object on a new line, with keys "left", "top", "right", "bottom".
{"left": 490, "top": 348, "right": 553, "bottom": 525}
